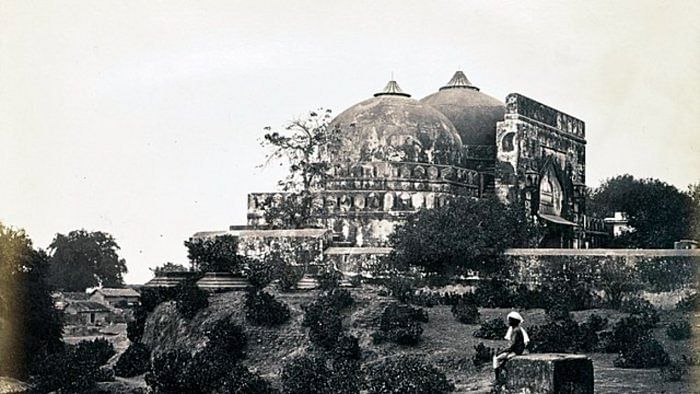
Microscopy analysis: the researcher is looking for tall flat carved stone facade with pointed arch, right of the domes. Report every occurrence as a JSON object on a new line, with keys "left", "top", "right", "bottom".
{"left": 495, "top": 94, "right": 589, "bottom": 247}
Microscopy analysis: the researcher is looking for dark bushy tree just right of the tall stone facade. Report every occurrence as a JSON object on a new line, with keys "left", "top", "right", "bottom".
{"left": 588, "top": 174, "right": 692, "bottom": 248}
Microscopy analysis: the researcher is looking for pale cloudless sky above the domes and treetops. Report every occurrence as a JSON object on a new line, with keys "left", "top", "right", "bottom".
{"left": 0, "top": 0, "right": 700, "bottom": 283}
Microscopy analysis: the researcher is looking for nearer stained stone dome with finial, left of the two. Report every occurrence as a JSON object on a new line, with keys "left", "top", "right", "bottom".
{"left": 330, "top": 81, "right": 462, "bottom": 165}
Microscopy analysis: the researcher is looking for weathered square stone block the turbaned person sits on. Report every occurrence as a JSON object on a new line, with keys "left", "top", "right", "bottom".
{"left": 495, "top": 353, "right": 593, "bottom": 394}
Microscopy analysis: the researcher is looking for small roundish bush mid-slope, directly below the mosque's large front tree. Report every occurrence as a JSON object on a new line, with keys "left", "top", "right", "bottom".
{"left": 373, "top": 304, "right": 428, "bottom": 345}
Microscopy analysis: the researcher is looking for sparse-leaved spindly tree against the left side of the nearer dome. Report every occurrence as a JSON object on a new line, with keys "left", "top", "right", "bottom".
{"left": 262, "top": 109, "right": 340, "bottom": 228}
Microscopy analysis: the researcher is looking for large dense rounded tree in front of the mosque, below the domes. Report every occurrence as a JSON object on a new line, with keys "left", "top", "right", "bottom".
{"left": 389, "top": 198, "right": 535, "bottom": 276}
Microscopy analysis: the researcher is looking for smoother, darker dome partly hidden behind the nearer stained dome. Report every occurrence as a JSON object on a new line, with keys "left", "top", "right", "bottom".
{"left": 420, "top": 71, "right": 505, "bottom": 145}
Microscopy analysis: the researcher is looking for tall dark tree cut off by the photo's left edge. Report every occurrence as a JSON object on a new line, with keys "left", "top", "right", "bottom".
{"left": 0, "top": 223, "right": 63, "bottom": 378}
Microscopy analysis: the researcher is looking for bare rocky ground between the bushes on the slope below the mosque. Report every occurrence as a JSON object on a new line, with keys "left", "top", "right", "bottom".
{"left": 119, "top": 288, "right": 700, "bottom": 393}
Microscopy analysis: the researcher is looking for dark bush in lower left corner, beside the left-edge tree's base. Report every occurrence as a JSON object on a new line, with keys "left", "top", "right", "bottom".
{"left": 30, "top": 339, "right": 114, "bottom": 393}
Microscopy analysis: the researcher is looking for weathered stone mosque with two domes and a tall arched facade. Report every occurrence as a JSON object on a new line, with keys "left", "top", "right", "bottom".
{"left": 194, "top": 71, "right": 605, "bottom": 272}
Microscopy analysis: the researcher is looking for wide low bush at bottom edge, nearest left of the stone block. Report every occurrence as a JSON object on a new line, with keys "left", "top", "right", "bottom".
{"left": 365, "top": 355, "right": 454, "bottom": 394}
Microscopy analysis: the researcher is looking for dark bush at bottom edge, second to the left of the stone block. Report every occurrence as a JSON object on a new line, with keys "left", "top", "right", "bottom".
{"left": 282, "top": 356, "right": 360, "bottom": 394}
